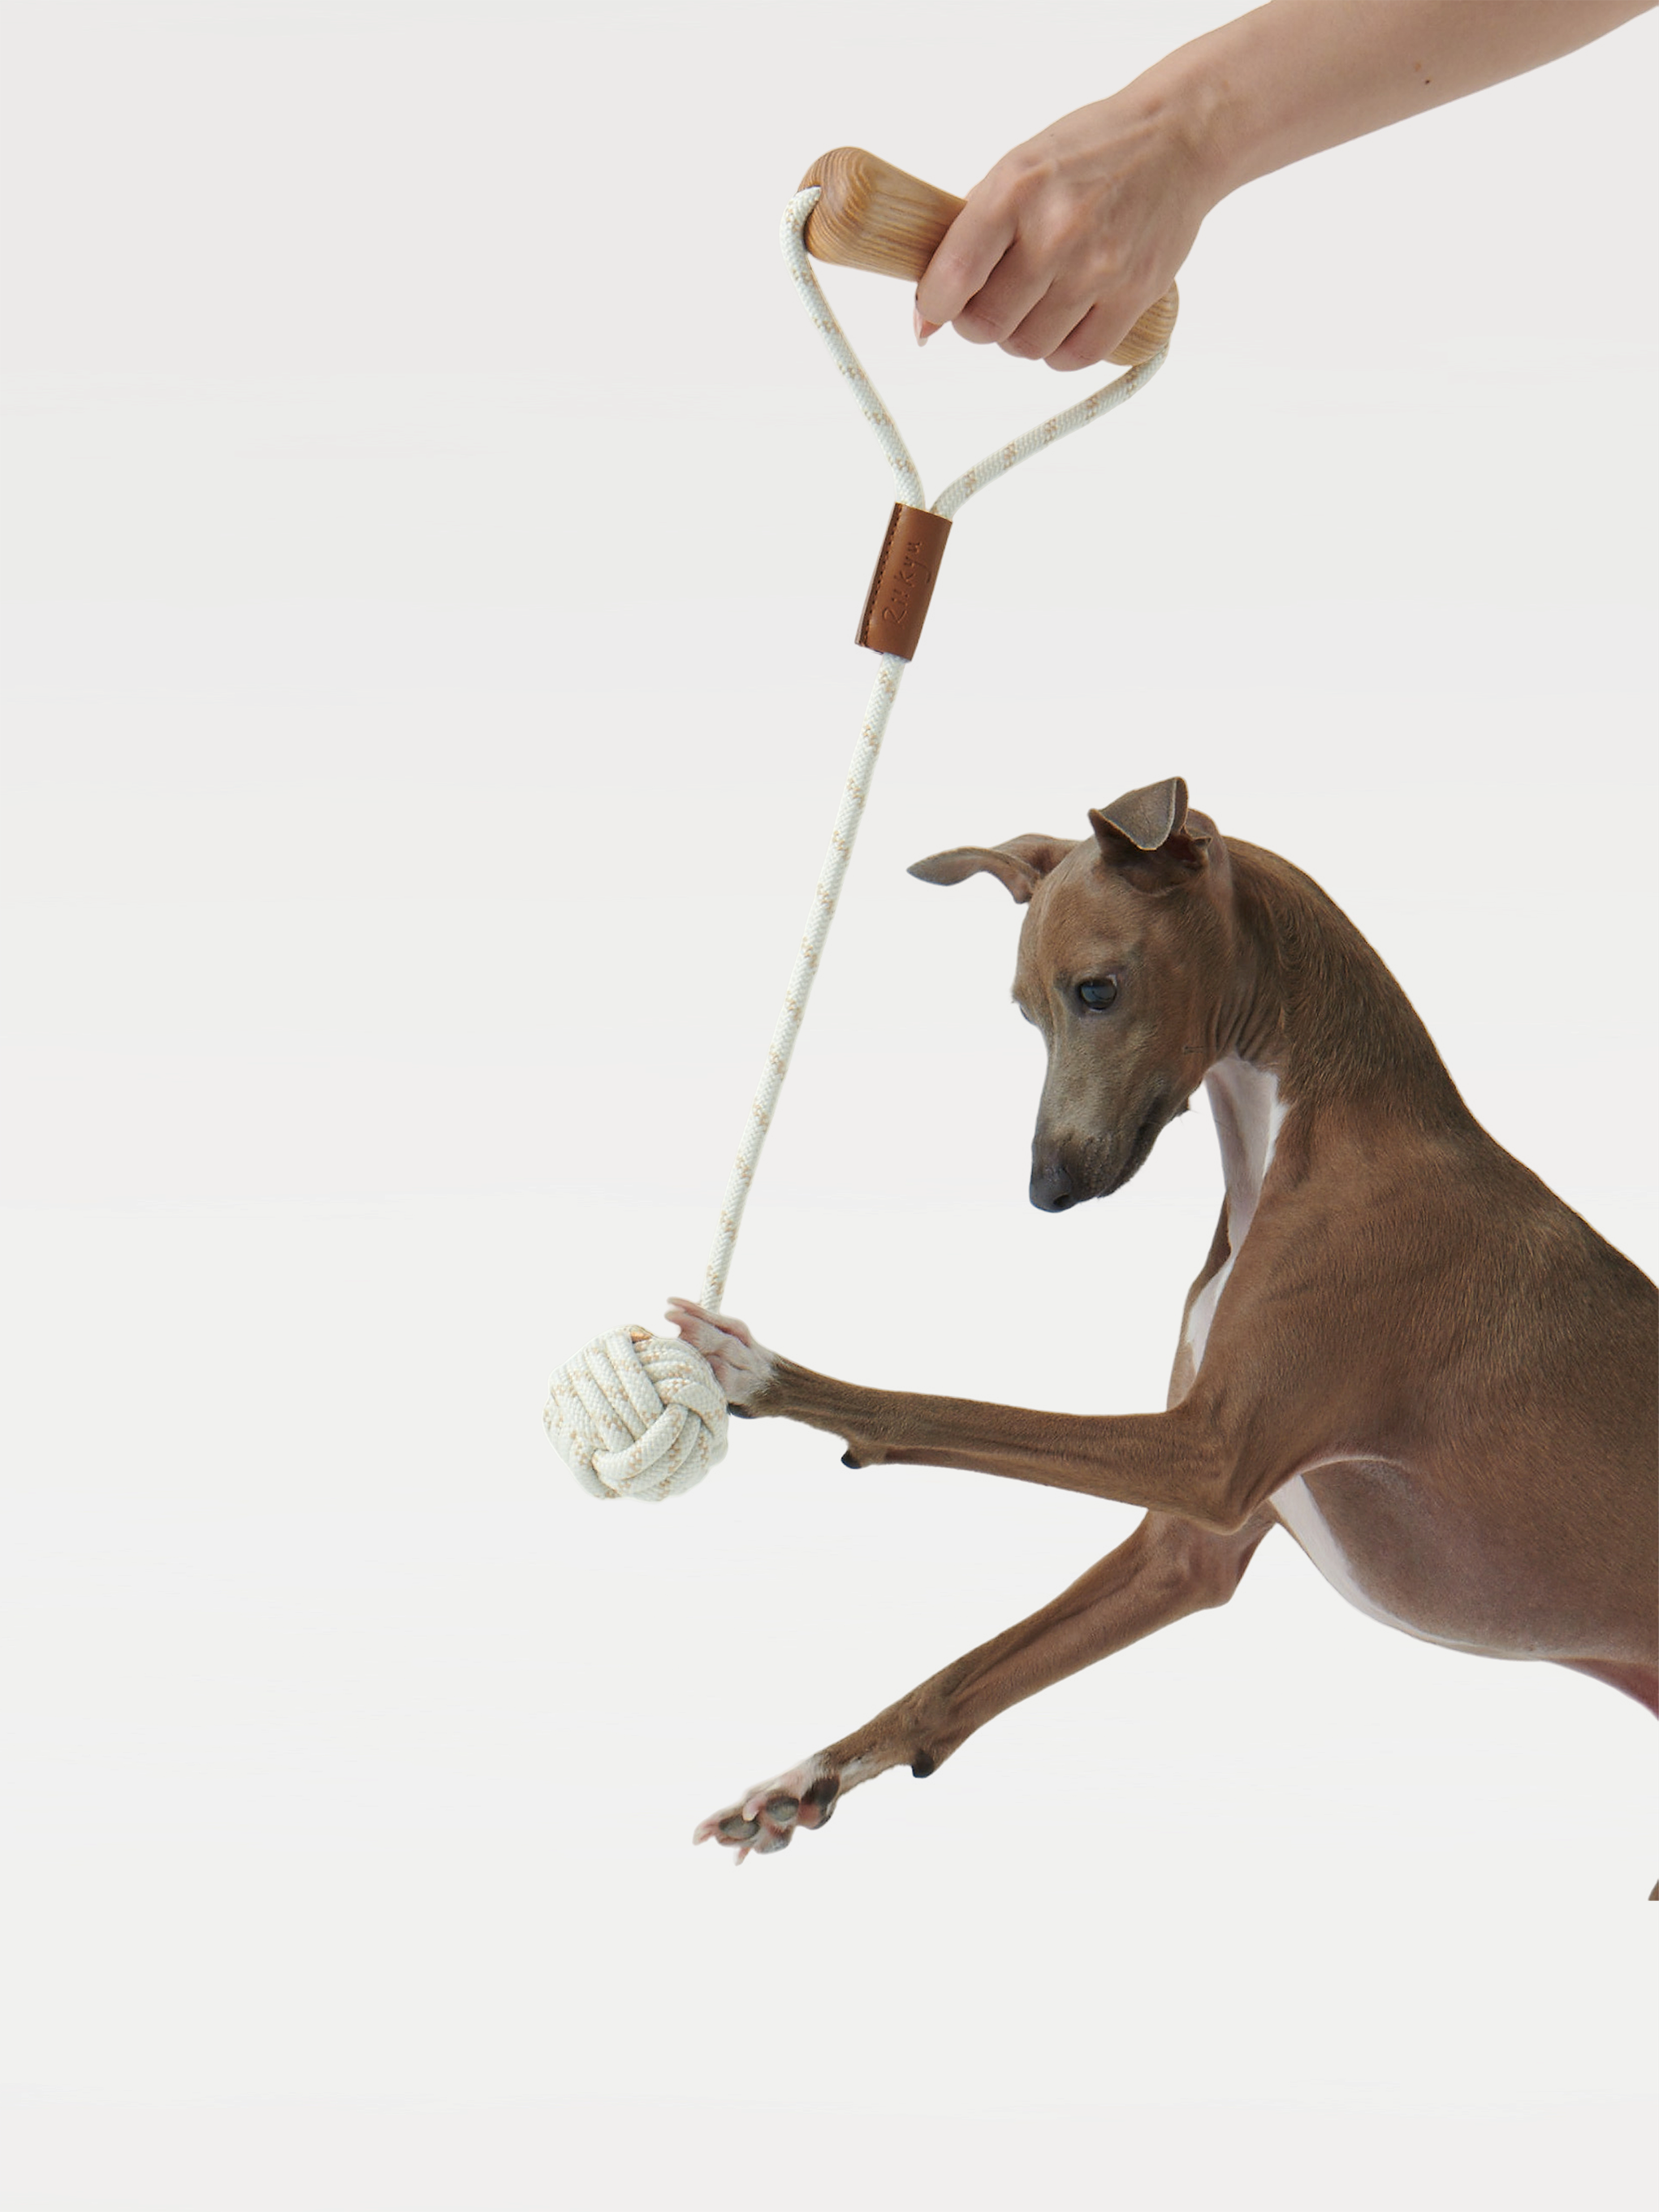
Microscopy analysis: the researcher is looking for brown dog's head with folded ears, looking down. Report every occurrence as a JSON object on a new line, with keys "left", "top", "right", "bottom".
{"left": 911, "top": 776, "right": 1232, "bottom": 1214}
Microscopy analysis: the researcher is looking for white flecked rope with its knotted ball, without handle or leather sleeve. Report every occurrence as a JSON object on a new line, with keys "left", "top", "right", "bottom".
{"left": 544, "top": 186, "right": 1168, "bottom": 1500}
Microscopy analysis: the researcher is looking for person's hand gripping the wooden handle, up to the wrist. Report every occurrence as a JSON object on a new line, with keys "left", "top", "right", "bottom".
{"left": 916, "top": 84, "right": 1221, "bottom": 369}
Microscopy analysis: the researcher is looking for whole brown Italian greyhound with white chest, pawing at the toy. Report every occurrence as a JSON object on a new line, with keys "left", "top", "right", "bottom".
{"left": 668, "top": 776, "right": 1659, "bottom": 1898}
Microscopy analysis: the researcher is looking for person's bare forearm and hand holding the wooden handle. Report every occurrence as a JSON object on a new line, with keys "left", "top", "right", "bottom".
{"left": 916, "top": 0, "right": 1655, "bottom": 369}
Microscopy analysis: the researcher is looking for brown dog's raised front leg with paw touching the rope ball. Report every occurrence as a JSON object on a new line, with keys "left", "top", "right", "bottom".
{"left": 668, "top": 1298, "right": 1256, "bottom": 1535}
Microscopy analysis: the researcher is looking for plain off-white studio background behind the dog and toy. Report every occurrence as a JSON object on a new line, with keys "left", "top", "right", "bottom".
{"left": 0, "top": 0, "right": 1659, "bottom": 2212}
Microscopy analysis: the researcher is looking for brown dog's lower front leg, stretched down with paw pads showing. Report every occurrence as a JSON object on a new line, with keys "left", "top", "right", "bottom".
{"left": 693, "top": 1513, "right": 1272, "bottom": 1863}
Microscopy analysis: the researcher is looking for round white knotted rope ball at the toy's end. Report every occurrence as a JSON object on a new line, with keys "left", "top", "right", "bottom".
{"left": 542, "top": 1327, "right": 725, "bottom": 1504}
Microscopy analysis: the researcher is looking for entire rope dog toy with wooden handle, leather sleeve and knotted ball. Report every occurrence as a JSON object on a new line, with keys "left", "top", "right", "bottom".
{"left": 544, "top": 146, "right": 1179, "bottom": 1502}
